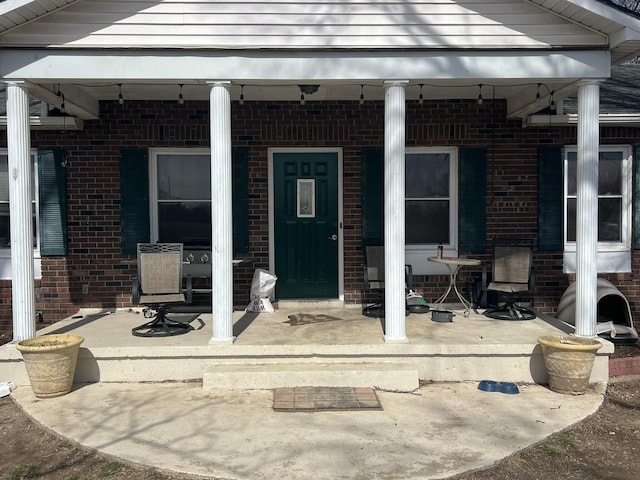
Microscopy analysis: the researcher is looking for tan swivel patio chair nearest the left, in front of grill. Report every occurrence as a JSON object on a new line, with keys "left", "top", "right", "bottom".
{"left": 131, "top": 243, "right": 193, "bottom": 337}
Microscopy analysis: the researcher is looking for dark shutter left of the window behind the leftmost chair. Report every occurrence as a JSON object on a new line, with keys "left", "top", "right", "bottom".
{"left": 120, "top": 148, "right": 151, "bottom": 254}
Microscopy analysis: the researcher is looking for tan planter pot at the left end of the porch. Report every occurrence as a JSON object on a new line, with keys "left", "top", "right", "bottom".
{"left": 16, "top": 334, "right": 84, "bottom": 398}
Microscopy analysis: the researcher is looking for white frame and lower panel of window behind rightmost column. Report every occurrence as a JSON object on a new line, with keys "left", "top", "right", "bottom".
{"left": 562, "top": 145, "right": 633, "bottom": 273}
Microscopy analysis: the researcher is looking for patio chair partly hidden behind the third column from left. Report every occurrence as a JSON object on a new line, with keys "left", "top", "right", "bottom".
{"left": 362, "top": 245, "right": 429, "bottom": 318}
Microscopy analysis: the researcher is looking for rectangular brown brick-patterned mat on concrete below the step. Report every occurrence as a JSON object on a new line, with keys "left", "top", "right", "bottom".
{"left": 273, "top": 387, "right": 382, "bottom": 412}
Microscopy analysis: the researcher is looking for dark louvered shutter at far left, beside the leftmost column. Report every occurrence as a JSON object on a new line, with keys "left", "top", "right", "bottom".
{"left": 38, "top": 149, "right": 67, "bottom": 256}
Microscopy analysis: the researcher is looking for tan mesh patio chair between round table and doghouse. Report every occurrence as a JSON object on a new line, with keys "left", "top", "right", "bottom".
{"left": 484, "top": 241, "right": 537, "bottom": 320}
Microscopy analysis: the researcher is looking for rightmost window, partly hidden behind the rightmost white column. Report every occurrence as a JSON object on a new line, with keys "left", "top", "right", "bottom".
{"left": 565, "top": 146, "right": 632, "bottom": 250}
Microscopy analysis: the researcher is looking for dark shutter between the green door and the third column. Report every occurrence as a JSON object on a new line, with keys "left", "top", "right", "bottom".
{"left": 362, "top": 147, "right": 384, "bottom": 245}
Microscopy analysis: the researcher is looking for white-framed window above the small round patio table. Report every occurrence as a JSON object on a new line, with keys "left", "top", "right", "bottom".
{"left": 405, "top": 148, "right": 457, "bottom": 249}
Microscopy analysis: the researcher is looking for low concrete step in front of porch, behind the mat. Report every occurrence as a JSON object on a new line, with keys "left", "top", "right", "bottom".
{"left": 202, "top": 363, "right": 419, "bottom": 392}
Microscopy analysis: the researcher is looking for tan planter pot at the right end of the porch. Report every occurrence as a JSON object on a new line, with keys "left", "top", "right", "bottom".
{"left": 538, "top": 335, "right": 602, "bottom": 395}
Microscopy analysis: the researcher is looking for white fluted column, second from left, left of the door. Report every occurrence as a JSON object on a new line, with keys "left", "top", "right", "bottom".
{"left": 209, "top": 82, "right": 235, "bottom": 343}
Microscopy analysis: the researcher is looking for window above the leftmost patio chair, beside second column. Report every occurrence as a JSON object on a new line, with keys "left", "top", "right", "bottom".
{"left": 150, "top": 149, "right": 211, "bottom": 246}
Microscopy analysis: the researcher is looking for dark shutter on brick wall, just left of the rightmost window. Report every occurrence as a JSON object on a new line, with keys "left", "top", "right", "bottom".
{"left": 538, "top": 146, "right": 564, "bottom": 250}
